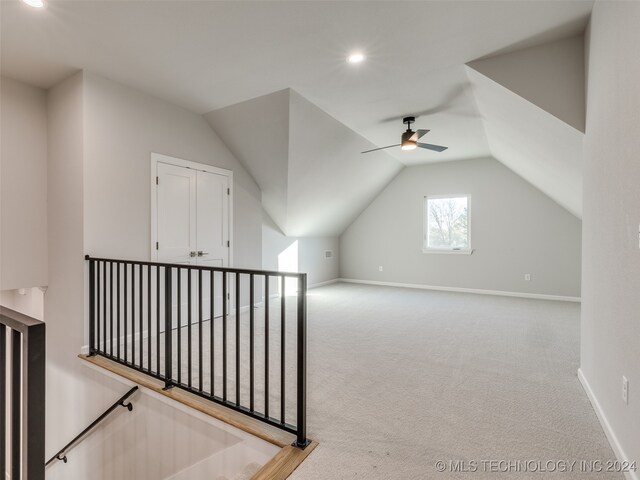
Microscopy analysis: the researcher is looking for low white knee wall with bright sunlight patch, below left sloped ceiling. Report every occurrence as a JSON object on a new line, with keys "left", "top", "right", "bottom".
{"left": 262, "top": 212, "right": 340, "bottom": 286}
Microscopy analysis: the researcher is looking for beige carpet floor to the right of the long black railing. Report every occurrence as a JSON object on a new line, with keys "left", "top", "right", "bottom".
{"left": 291, "top": 284, "right": 622, "bottom": 480}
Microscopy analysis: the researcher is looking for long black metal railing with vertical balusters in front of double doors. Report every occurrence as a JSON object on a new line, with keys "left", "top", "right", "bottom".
{"left": 85, "top": 256, "right": 309, "bottom": 448}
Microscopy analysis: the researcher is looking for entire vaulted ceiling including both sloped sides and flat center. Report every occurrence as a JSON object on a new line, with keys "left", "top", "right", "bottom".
{"left": 0, "top": 0, "right": 593, "bottom": 235}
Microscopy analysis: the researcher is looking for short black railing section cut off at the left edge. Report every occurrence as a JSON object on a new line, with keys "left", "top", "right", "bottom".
{"left": 0, "top": 307, "right": 46, "bottom": 480}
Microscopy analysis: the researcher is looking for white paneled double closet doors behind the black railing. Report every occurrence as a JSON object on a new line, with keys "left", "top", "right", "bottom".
{"left": 155, "top": 162, "right": 230, "bottom": 326}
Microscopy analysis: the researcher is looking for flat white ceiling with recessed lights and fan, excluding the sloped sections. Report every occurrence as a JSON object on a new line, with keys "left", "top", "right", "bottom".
{"left": 0, "top": 0, "right": 593, "bottom": 164}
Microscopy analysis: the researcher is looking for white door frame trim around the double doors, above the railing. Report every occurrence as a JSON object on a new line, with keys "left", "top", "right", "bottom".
{"left": 149, "top": 152, "right": 233, "bottom": 267}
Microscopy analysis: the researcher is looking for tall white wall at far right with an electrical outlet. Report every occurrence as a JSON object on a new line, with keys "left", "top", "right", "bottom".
{"left": 580, "top": 2, "right": 640, "bottom": 472}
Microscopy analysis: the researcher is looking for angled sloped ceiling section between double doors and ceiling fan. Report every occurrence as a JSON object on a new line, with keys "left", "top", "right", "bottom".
{"left": 205, "top": 89, "right": 403, "bottom": 237}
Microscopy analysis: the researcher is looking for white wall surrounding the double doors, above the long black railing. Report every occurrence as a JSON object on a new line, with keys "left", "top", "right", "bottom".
{"left": 84, "top": 73, "right": 262, "bottom": 268}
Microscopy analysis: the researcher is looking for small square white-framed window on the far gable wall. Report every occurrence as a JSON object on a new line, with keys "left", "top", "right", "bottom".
{"left": 422, "top": 195, "right": 472, "bottom": 254}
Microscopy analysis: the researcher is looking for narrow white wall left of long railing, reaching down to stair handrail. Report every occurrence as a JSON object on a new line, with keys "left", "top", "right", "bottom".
{"left": 44, "top": 69, "right": 110, "bottom": 466}
